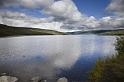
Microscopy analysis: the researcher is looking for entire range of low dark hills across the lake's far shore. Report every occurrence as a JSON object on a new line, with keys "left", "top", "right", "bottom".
{"left": 0, "top": 24, "right": 124, "bottom": 37}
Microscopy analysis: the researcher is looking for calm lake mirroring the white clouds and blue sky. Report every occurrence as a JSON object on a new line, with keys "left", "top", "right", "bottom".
{"left": 0, "top": 34, "right": 116, "bottom": 82}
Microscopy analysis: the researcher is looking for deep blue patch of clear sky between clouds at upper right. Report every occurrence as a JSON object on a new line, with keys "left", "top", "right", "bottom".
{"left": 73, "top": 0, "right": 110, "bottom": 18}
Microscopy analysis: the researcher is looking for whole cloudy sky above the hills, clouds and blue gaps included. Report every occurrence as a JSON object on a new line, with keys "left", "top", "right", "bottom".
{"left": 0, "top": 0, "right": 124, "bottom": 31}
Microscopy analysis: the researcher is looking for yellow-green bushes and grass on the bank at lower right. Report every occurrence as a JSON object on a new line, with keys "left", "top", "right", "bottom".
{"left": 89, "top": 37, "right": 124, "bottom": 82}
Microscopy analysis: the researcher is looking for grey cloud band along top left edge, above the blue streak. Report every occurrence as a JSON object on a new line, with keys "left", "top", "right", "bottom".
{"left": 0, "top": 0, "right": 54, "bottom": 8}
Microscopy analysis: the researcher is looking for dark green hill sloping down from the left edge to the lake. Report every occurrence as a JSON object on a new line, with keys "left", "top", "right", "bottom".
{"left": 0, "top": 24, "right": 64, "bottom": 37}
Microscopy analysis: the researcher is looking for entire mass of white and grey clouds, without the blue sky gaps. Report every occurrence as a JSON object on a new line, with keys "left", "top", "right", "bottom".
{"left": 0, "top": 0, "right": 124, "bottom": 31}
